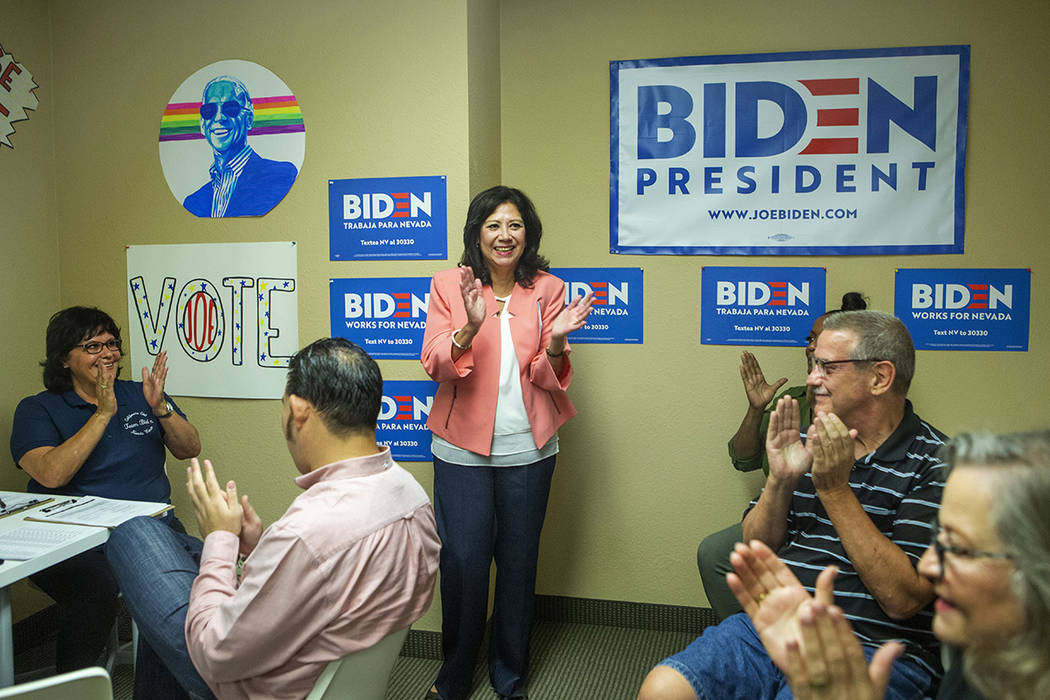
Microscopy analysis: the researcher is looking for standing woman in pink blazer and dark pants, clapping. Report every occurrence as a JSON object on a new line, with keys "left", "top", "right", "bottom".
{"left": 420, "top": 187, "right": 591, "bottom": 700}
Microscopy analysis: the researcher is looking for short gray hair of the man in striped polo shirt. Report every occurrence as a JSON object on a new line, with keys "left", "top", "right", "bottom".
{"left": 823, "top": 310, "right": 916, "bottom": 397}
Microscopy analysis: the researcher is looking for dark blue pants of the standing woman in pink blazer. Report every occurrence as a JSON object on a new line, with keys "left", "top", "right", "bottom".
{"left": 434, "top": 455, "right": 557, "bottom": 700}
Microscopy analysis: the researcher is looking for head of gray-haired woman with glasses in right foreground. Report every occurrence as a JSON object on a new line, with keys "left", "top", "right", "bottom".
{"left": 919, "top": 430, "right": 1050, "bottom": 699}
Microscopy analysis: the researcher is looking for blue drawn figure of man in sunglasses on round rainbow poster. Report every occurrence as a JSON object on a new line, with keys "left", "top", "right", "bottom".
{"left": 183, "top": 76, "right": 298, "bottom": 218}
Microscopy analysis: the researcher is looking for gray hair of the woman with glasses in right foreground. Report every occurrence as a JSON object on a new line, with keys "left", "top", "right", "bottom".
{"left": 946, "top": 430, "right": 1050, "bottom": 700}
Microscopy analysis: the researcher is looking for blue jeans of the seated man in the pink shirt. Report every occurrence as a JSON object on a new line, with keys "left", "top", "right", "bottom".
{"left": 106, "top": 517, "right": 214, "bottom": 699}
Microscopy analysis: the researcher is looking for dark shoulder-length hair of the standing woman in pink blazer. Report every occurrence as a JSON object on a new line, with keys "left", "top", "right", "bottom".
{"left": 460, "top": 185, "right": 550, "bottom": 287}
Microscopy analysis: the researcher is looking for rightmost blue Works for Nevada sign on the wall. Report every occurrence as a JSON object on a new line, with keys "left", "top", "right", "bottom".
{"left": 894, "top": 269, "right": 1032, "bottom": 351}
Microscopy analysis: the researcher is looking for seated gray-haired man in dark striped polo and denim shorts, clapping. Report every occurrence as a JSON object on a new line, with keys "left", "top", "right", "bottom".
{"left": 638, "top": 311, "right": 944, "bottom": 700}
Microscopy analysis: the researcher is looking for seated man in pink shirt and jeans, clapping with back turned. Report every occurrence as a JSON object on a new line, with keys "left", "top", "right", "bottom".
{"left": 107, "top": 338, "right": 440, "bottom": 698}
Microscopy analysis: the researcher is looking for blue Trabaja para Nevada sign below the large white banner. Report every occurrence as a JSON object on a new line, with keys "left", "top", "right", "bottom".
{"left": 700, "top": 268, "right": 827, "bottom": 346}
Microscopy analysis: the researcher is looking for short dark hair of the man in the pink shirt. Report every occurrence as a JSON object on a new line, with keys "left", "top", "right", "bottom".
{"left": 285, "top": 338, "right": 383, "bottom": 436}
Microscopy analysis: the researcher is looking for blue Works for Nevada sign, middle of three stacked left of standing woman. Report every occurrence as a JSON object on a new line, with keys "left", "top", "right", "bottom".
{"left": 329, "top": 277, "right": 431, "bottom": 360}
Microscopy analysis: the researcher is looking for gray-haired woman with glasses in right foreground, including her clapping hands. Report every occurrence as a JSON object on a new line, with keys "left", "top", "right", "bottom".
{"left": 727, "top": 430, "right": 1050, "bottom": 700}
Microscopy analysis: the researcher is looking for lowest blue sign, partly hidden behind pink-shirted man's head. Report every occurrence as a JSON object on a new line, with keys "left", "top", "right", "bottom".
{"left": 376, "top": 380, "right": 438, "bottom": 462}
